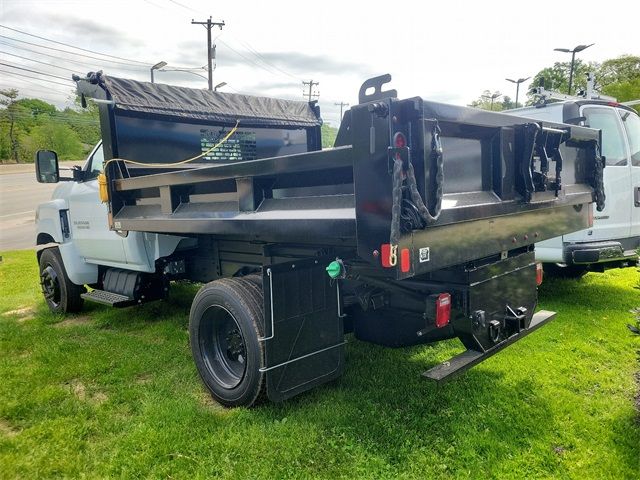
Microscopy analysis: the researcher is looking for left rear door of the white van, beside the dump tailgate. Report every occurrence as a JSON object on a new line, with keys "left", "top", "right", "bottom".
{"left": 564, "top": 105, "right": 632, "bottom": 242}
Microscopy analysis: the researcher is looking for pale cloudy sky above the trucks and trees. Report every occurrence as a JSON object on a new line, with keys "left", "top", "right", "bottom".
{"left": 0, "top": 0, "right": 640, "bottom": 125}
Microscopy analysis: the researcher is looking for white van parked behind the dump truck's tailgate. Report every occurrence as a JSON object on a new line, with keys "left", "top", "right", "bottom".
{"left": 507, "top": 99, "right": 640, "bottom": 277}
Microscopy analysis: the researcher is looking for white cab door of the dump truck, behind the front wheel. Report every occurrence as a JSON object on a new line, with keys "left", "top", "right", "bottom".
{"left": 68, "top": 143, "right": 126, "bottom": 266}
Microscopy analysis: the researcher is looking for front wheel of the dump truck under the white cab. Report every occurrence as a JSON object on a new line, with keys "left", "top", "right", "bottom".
{"left": 40, "top": 248, "right": 85, "bottom": 313}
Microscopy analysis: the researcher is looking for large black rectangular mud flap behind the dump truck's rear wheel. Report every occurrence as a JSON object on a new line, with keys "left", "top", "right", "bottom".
{"left": 261, "top": 258, "right": 344, "bottom": 402}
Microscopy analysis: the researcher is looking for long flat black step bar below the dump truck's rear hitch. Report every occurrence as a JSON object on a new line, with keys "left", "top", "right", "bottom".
{"left": 422, "top": 310, "right": 556, "bottom": 383}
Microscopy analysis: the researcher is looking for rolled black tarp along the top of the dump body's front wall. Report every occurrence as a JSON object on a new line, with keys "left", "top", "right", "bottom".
{"left": 101, "top": 75, "right": 322, "bottom": 128}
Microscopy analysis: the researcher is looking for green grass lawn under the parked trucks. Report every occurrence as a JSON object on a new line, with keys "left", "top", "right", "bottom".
{"left": 0, "top": 252, "right": 640, "bottom": 479}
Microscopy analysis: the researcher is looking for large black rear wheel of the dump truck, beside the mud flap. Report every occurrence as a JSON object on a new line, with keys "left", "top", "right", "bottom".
{"left": 189, "top": 278, "right": 265, "bottom": 407}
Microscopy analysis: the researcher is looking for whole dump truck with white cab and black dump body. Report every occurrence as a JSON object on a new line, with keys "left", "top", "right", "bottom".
{"left": 37, "top": 74, "right": 604, "bottom": 406}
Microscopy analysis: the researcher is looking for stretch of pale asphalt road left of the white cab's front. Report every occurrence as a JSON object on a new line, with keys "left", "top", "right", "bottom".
{"left": 0, "top": 165, "right": 76, "bottom": 252}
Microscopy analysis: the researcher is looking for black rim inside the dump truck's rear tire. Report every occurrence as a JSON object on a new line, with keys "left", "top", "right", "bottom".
{"left": 200, "top": 305, "right": 247, "bottom": 390}
